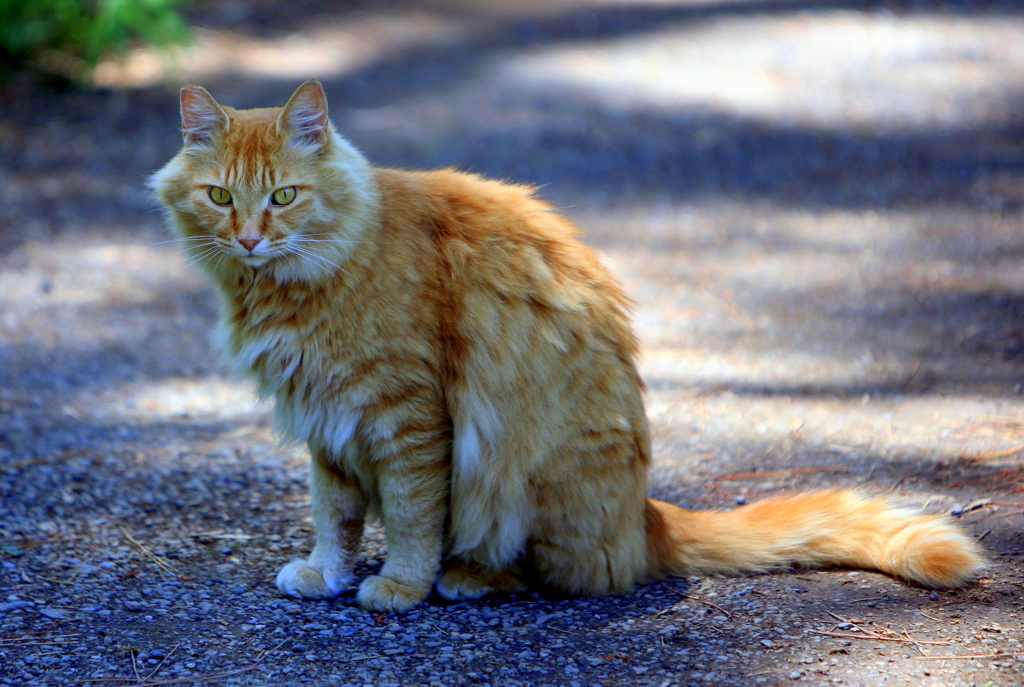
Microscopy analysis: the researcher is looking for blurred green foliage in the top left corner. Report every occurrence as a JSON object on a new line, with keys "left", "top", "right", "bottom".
{"left": 0, "top": 0, "right": 189, "bottom": 78}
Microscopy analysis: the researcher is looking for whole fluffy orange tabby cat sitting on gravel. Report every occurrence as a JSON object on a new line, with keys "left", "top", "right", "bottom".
{"left": 152, "top": 81, "right": 983, "bottom": 612}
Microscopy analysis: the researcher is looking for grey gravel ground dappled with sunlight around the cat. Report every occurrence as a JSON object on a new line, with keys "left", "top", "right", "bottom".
{"left": 0, "top": 0, "right": 1024, "bottom": 687}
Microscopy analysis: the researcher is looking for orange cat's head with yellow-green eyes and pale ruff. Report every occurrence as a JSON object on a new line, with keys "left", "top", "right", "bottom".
{"left": 150, "top": 80, "right": 377, "bottom": 281}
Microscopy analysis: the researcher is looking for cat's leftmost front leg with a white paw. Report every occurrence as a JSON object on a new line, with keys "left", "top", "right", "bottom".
{"left": 278, "top": 448, "right": 366, "bottom": 599}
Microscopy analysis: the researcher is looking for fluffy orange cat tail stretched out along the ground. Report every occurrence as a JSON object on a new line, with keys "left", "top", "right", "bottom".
{"left": 646, "top": 490, "right": 985, "bottom": 588}
